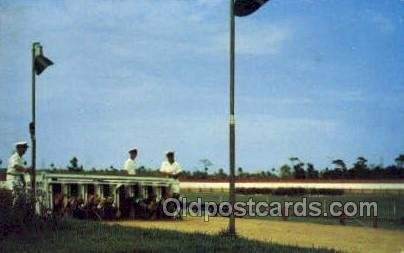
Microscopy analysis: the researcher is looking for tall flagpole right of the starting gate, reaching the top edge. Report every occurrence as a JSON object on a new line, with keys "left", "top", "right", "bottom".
{"left": 229, "top": 0, "right": 236, "bottom": 236}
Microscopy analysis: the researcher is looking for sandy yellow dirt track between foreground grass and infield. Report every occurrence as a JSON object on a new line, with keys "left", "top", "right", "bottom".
{"left": 109, "top": 217, "right": 404, "bottom": 253}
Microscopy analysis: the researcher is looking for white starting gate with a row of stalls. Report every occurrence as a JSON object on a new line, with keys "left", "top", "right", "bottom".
{"left": 36, "top": 172, "right": 179, "bottom": 210}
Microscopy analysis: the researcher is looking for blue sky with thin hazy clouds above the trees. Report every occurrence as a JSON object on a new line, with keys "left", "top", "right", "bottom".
{"left": 0, "top": 0, "right": 404, "bottom": 171}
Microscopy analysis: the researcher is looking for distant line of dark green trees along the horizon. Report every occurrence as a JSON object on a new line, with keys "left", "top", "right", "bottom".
{"left": 1, "top": 154, "right": 404, "bottom": 179}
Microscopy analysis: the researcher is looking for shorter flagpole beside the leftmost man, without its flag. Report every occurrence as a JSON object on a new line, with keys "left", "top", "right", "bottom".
{"left": 29, "top": 42, "right": 39, "bottom": 197}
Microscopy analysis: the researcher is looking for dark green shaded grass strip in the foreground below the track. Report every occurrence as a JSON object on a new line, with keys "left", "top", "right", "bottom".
{"left": 0, "top": 220, "right": 336, "bottom": 253}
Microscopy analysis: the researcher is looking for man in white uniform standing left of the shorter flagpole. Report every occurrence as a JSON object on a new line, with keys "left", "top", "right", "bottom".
{"left": 7, "top": 141, "right": 30, "bottom": 190}
